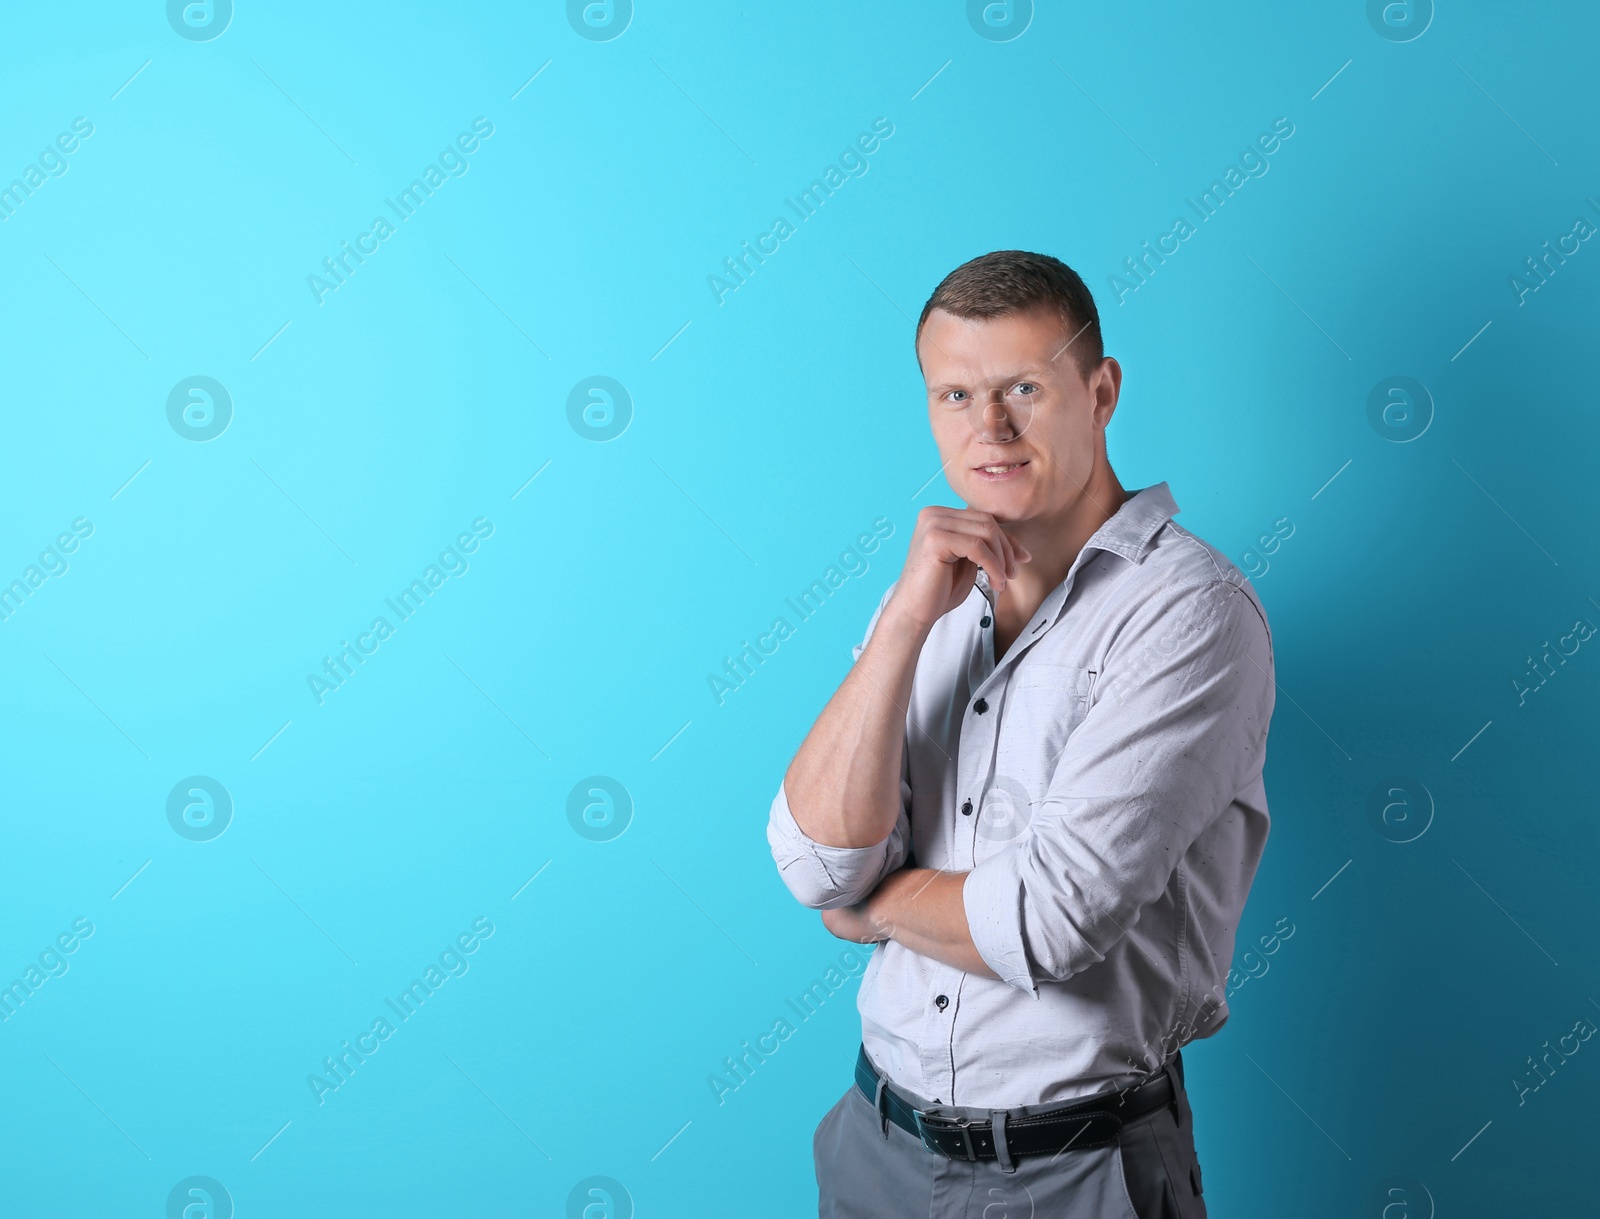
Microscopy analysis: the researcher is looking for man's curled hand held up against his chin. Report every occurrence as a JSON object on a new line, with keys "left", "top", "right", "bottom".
{"left": 890, "top": 506, "right": 1032, "bottom": 630}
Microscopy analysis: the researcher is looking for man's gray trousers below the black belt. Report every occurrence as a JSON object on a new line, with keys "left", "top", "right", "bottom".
{"left": 811, "top": 1059, "right": 1206, "bottom": 1219}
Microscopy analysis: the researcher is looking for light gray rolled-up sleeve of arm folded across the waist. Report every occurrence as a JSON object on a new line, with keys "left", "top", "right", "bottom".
{"left": 963, "top": 579, "right": 1275, "bottom": 993}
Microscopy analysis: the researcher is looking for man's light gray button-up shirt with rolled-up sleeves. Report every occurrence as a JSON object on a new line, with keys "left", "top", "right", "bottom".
{"left": 766, "top": 483, "right": 1275, "bottom": 1109}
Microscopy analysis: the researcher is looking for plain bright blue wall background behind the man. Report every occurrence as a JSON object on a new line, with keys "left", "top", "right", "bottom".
{"left": 0, "top": 0, "right": 1600, "bottom": 1219}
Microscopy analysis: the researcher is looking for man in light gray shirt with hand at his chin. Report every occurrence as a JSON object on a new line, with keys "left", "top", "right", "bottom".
{"left": 768, "top": 251, "right": 1274, "bottom": 1219}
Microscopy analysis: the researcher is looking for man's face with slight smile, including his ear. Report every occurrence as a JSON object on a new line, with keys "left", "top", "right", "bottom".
{"left": 917, "top": 309, "right": 1122, "bottom": 523}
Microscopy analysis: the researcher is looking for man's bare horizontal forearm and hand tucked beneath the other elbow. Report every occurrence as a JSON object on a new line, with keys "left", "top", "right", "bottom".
{"left": 822, "top": 867, "right": 998, "bottom": 977}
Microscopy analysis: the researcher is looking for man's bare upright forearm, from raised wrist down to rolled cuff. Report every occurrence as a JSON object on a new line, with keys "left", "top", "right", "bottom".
{"left": 784, "top": 606, "right": 928, "bottom": 846}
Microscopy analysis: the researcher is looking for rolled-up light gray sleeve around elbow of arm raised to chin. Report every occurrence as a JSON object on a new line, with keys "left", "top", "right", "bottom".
{"left": 766, "top": 581, "right": 910, "bottom": 910}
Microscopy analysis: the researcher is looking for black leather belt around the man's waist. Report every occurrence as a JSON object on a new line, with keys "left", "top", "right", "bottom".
{"left": 856, "top": 1046, "right": 1182, "bottom": 1168}
